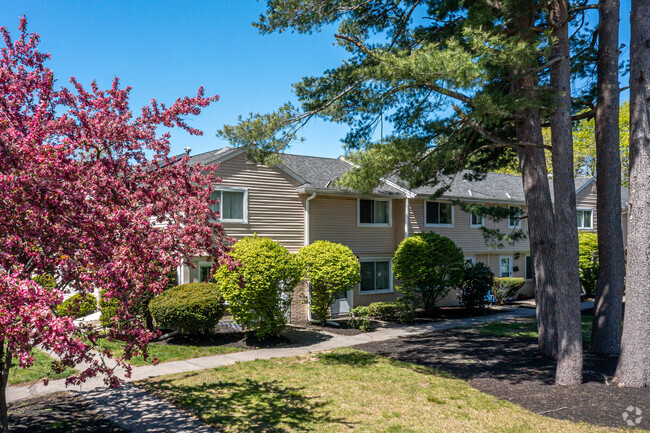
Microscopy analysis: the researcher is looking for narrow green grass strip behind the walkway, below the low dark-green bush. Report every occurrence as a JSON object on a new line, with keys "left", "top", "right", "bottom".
{"left": 99, "top": 340, "right": 245, "bottom": 367}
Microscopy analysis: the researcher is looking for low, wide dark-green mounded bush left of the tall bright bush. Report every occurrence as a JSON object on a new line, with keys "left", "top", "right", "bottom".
{"left": 149, "top": 283, "right": 226, "bottom": 334}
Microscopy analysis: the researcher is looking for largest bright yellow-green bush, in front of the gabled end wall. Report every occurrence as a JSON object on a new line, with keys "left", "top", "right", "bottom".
{"left": 214, "top": 236, "right": 304, "bottom": 338}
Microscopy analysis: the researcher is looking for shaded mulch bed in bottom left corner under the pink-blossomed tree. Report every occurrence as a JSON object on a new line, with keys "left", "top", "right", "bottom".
{"left": 8, "top": 392, "right": 129, "bottom": 433}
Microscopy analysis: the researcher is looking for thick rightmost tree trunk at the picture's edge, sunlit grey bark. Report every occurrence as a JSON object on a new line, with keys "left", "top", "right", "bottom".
{"left": 614, "top": 0, "right": 650, "bottom": 388}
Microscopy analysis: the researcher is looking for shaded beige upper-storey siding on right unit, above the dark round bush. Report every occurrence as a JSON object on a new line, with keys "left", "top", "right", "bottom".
{"left": 409, "top": 199, "right": 530, "bottom": 255}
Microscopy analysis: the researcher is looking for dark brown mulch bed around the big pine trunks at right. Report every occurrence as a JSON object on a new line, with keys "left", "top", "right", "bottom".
{"left": 355, "top": 320, "right": 650, "bottom": 429}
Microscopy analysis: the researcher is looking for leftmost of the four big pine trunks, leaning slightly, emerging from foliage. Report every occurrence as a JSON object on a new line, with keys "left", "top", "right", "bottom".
{"left": 516, "top": 115, "right": 557, "bottom": 359}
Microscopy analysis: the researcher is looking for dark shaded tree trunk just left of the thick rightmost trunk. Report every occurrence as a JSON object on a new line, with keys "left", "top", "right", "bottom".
{"left": 590, "top": 0, "right": 625, "bottom": 355}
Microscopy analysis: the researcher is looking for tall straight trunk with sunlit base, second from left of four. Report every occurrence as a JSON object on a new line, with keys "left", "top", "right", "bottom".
{"left": 550, "top": 0, "right": 582, "bottom": 385}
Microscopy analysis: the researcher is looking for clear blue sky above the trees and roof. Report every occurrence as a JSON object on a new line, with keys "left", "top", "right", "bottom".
{"left": 0, "top": 0, "right": 630, "bottom": 157}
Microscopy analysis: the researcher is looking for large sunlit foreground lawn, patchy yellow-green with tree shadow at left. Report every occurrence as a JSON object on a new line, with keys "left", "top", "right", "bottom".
{"left": 138, "top": 349, "right": 617, "bottom": 433}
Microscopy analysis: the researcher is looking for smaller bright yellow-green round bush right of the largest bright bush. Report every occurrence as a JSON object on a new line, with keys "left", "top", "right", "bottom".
{"left": 297, "top": 241, "right": 361, "bottom": 324}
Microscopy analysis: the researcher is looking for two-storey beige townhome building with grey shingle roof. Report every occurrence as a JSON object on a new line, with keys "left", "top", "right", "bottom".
{"left": 178, "top": 147, "right": 627, "bottom": 321}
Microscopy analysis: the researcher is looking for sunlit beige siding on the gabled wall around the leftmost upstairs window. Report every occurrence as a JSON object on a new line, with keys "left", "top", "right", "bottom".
{"left": 217, "top": 154, "right": 305, "bottom": 252}
